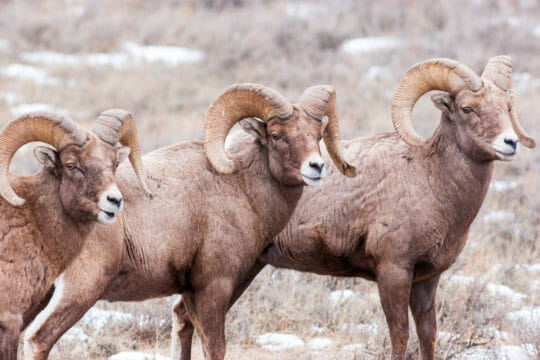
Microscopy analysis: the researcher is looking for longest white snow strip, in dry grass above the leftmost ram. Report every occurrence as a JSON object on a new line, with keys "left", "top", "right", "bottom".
{"left": 21, "top": 42, "right": 205, "bottom": 68}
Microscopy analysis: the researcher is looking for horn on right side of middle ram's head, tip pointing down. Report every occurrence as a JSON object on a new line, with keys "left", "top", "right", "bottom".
{"left": 299, "top": 85, "right": 356, "bottom": 177}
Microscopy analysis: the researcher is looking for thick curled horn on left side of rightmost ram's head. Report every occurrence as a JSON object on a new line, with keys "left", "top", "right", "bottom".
{"left": 392, "top": 59, "right": 483, "bottom": 146}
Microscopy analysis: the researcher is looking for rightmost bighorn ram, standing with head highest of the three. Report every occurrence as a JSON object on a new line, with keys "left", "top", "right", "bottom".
{"left": 173, "top": 56, "right": 535, "bottom": 360}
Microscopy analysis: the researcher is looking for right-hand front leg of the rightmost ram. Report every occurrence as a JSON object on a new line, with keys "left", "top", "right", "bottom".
{"left": 409, "top": 275, "right": 439, "bottom": 360}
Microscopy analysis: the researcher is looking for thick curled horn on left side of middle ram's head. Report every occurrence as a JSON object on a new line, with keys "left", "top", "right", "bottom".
{"left": 204, "top": 83, "right": 293, "bottom": 174}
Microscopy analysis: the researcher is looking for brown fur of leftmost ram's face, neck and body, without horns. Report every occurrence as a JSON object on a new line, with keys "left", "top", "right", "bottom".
{"left": 0, "top": 133, "right": 127, "bottom": 360}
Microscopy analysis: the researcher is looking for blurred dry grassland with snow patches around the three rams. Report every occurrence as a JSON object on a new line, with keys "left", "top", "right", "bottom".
{"left": 0, "top": 0, "right": 540, "bottom": 360}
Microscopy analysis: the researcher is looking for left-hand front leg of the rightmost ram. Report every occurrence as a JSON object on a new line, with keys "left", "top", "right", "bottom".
{"left": 377, "top": 262, "right": 412, "bottom": 360}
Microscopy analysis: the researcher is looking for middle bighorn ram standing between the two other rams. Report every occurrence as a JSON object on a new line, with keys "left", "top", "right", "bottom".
{"left": 25, "top": 84, "right": 355, "bottom": 360}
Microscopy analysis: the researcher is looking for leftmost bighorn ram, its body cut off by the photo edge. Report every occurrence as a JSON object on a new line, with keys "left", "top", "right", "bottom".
{"left": 0, "top": 110, "right": 150, "bottom": 360}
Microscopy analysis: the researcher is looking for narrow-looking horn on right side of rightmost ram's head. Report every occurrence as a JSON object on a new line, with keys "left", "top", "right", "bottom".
{"left": 482, "top": 55, "right": 536, "bottom": 149}
